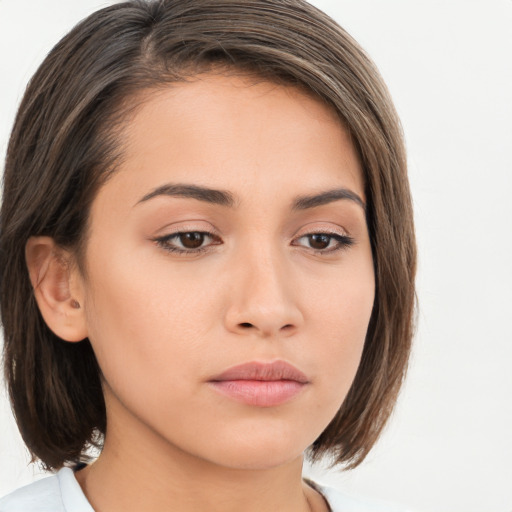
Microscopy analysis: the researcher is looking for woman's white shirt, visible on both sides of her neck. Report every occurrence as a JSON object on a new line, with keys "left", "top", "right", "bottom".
{"left": 0, "top": 468, "right": 406, "bottom": 512}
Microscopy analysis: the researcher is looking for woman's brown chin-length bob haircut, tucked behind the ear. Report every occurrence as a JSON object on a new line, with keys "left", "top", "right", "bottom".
{"left": 0, "top": 0, "right": 416, "bottom": 469}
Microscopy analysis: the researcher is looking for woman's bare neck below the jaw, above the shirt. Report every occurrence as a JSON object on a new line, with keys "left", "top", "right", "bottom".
{"left": 77, "top": 410, "right": 327, "bottom": 512}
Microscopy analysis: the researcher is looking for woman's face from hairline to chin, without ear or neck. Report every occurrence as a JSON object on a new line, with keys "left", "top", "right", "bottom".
{"left": 80, "top": 75, "right": 374, "bottom": 468}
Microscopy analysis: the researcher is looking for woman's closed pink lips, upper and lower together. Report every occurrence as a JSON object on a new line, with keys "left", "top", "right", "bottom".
{"left": 208, "top": 361, "right": 309, "bottom": 407}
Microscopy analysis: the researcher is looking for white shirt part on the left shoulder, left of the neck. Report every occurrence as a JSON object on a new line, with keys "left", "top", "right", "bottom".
{"left": 0, "top": 468, "right": 94, "bottom": 512}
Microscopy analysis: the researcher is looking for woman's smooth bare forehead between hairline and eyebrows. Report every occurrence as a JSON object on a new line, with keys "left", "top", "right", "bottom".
{"left": 93, "top": 74, "right": 364, "bottom": 213}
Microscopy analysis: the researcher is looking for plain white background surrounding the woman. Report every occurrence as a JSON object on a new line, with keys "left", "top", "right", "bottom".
{"left": 0, "top": 0, "right": 512, "bottom": 512}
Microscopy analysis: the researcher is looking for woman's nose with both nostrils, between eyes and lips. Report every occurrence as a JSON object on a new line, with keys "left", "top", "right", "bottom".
{"left": 225, "top": 245, "right": 303, "bottom": 337}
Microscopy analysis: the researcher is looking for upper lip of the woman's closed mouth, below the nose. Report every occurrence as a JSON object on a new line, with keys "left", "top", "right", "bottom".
{"left": 210, "top": 361, "right": 309, "bottom": 384}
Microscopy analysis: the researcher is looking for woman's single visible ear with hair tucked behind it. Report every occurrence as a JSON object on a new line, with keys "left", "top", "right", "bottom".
{"left": 25, "top": 236, "right": 88, "bottom": 342}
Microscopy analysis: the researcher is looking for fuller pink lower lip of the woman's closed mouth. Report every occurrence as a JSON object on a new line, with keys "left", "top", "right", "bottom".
{"left": 210, "top": 380, "right": 305, "bottom": 407}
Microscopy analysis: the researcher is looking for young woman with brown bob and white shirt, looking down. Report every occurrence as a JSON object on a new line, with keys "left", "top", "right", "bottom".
{"left": 0, "top": 0, "right": 415, "bottom": 512}
